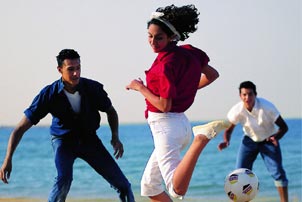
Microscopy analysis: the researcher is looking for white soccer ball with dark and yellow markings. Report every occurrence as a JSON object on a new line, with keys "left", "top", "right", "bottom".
{"left": 224, "top": 168, "right": 259, "bottom": 202}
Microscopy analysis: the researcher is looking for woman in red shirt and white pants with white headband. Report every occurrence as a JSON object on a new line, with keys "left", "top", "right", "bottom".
{"left": 126, "top": 5, "right": 219, "bottom": 202}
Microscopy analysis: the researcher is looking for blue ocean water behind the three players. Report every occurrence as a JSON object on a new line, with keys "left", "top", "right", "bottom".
{"left": 0, "top": 119, "right": 302, "bottom": 201}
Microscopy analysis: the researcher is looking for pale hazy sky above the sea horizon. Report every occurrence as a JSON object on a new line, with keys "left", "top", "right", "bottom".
{"left": 0, "top": 0, "right": 302, "bottom": 126}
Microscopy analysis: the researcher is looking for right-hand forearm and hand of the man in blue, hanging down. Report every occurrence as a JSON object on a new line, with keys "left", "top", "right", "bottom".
{"left": 106, "top": 106, "right": 124, "bottom": 159}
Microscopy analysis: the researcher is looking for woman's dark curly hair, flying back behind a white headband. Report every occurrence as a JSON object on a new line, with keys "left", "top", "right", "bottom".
{"left": 147, "top": 4, "right": 200, "bottom": 41}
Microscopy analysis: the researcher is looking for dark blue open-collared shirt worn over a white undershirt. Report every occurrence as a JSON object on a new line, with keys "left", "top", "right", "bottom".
{"left": 24, "top": 78, "right": 112, "bottom": 136}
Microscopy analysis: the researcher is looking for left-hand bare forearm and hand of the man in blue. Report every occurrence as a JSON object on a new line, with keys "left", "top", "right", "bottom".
{"left": 0, "top": 116, "right": 32, "bottom": 184}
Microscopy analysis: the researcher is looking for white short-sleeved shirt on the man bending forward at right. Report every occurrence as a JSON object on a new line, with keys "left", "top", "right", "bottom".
{"left": 227, "top": 97, "right": 280, "bottom": 142}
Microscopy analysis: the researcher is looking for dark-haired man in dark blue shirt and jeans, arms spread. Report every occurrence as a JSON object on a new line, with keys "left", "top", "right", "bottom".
{"left": 0, "top": 49, "right": 134, "bottom": 202}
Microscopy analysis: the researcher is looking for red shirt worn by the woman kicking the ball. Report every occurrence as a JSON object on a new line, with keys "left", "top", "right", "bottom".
{"left": 145, "top": 43, "right": 209, "bottom": 118}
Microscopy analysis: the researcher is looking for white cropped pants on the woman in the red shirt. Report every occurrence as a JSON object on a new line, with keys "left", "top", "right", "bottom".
{"left": 141, "top": 112, "right": 192, "bottom": 197}
